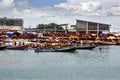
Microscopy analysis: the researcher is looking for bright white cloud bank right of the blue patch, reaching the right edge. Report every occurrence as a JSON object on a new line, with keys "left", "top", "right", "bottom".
{"left": 54, "top": 0, "right": 120, "bottom": 16}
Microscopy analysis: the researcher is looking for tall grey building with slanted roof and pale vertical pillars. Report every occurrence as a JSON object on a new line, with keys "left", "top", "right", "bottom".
{"left": 76, "top": 20, "right": 111, "bottom": 34}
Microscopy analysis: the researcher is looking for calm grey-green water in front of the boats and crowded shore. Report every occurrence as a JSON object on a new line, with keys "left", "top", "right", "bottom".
{"left": 0, "top": 46, "right": 120, "bottom": 80}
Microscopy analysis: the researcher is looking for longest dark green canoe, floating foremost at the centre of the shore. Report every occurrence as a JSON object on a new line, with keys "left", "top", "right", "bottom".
{"left": 35, "top": 46, "right": 76, "bottom": 52}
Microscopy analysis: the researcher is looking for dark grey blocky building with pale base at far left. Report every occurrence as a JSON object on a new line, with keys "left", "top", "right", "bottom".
{"left": 0, "top": 17, "right": 23, "bottom": 31}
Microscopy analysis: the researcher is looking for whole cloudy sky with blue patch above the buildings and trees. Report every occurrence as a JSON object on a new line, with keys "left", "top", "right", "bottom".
{"left": 0, "top": 0, "right": 120, "bottom": 31}
